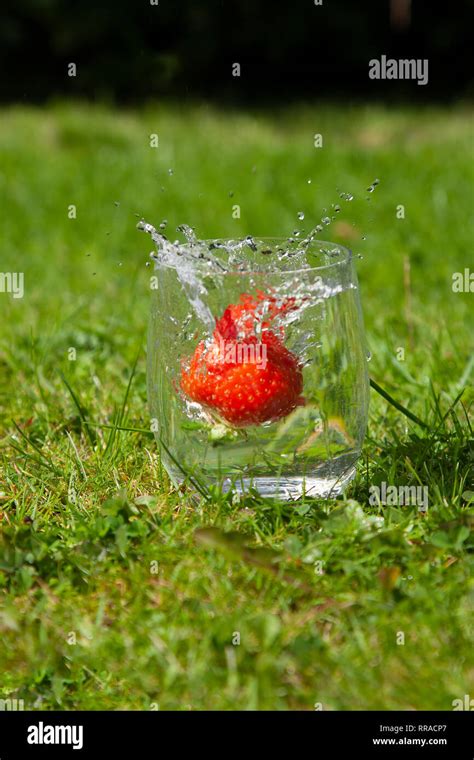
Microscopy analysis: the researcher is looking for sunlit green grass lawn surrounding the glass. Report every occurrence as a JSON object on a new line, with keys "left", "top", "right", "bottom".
{"left": 0, "top": 98, "right": 474, "bottom": 710}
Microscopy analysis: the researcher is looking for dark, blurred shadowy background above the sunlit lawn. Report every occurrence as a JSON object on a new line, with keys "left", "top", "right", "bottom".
{"left": 0, "top": 0, "right": 474, "bottom": 102}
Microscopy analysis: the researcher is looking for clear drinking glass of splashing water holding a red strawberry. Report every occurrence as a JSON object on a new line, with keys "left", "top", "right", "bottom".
{"left": 148, "top": 239, "right": 369, "bottom": 500}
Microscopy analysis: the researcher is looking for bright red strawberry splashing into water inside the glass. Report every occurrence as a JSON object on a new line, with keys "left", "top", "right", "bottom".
{"left": 181, "top": 292, "right": 304, "bottom": 427}
